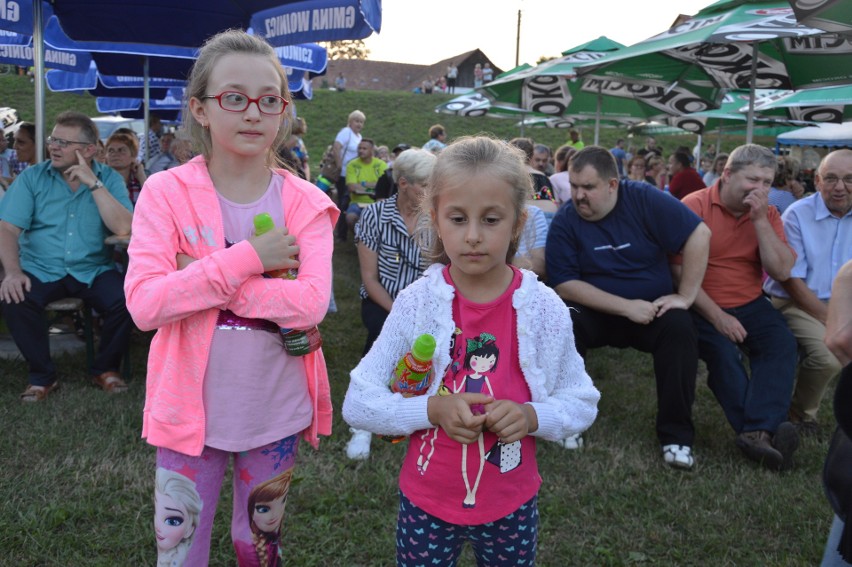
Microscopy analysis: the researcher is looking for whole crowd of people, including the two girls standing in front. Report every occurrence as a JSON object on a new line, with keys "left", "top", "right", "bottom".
{"left": 0, "top": 31, "right": 852, "bottom": 566}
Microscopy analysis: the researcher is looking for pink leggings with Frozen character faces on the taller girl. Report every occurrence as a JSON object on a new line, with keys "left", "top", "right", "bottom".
{"left": 154, "top": 435, "right": 299, "bottom": 567}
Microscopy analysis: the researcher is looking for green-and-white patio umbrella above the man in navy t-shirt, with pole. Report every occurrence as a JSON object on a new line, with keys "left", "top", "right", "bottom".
{"left": 472, "top": 37, "right": 720, "bottom": 143}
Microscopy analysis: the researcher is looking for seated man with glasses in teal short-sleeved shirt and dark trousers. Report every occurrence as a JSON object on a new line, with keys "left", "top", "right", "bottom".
{"left": 0, "top": 112, "right": 133, "bottom": 402}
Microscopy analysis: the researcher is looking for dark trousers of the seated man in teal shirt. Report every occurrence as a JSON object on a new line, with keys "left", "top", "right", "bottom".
{"left": 3, "top": 270, "right": 133, "bottom": 386}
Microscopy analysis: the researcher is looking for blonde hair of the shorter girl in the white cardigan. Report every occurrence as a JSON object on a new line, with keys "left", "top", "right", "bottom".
{"left": 418, "top": 136, "right": 533, "bottom": 264}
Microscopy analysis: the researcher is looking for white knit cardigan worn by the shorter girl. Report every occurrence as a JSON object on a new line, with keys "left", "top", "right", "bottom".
{"left": 343, "top": 264, "right": 600, "bottom": 441}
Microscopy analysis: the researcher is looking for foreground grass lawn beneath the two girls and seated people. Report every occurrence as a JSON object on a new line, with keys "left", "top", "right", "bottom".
{"left": 0, "top": 243, "right": 831, "bottom": 566}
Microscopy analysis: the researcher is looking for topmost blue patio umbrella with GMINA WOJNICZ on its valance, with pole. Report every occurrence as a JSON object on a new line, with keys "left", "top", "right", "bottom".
{"left": 0, "top": 0, "right": 381, "bottom": 160}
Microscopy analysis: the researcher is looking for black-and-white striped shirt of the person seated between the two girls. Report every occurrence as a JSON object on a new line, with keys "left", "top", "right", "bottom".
{"left": 355, "top": 195, "right": 425, "bottom": 299}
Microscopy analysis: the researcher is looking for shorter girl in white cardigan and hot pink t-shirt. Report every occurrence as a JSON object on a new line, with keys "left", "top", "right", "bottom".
{"left": 343, "top": 137, "right": 600, "bottom": 565}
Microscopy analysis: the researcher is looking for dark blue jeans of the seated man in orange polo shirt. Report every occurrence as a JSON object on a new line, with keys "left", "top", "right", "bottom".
{"left": 692, "top": 296, "right": 797, "bottom": 433}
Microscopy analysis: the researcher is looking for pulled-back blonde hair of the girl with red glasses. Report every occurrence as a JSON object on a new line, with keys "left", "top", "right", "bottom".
{"left": 184, "top": 30, "right": 293, "bottom": 167}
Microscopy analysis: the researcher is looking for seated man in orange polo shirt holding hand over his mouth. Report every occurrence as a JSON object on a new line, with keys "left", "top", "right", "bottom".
{"left": 683, "top": 144, "right": 799, "bottom": 470}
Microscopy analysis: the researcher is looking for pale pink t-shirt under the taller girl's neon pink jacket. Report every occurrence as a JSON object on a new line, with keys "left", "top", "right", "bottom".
{"left": 204, "top": 175, "right": 312, "bottom": 452}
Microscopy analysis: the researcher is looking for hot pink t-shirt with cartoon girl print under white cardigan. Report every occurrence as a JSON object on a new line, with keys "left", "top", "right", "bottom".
{"left": 399, "top": 268, "right": 541, "bottom": 525}
